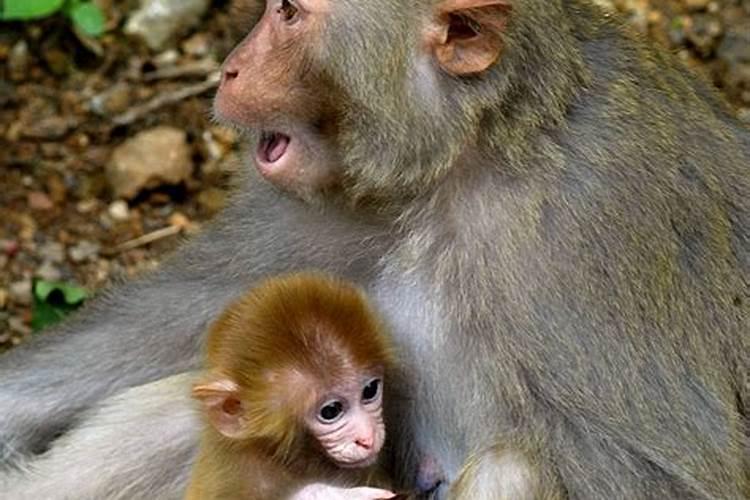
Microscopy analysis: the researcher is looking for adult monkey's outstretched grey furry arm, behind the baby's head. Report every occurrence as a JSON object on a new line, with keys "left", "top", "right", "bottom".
{"left": 0, "top": 180, "right": 384, "bottom": 464}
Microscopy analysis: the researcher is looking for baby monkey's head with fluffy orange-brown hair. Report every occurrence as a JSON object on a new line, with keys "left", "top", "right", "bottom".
{"left": 193, "top": 274, "right": 391, "bottom": 467}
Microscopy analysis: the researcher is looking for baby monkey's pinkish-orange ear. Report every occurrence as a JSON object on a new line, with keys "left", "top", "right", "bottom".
{"left": 193, "top": 378, "right": 245, "bottom": 439}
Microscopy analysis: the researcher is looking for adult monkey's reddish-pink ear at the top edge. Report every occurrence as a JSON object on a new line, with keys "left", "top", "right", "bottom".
{"left": 428, "top": 0, "right": 512, "bottom": 76}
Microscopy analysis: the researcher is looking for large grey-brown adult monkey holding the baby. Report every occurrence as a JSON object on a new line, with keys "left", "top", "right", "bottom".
{"left": 0, "top": 0, "right": 750, "bottom": 498}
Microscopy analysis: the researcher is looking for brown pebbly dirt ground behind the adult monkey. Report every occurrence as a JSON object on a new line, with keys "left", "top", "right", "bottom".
{"left": 0, "top": 0, "right": 750, "bottom": 351}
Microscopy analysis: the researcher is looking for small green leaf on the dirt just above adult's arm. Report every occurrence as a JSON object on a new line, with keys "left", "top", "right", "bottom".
{"left": 31, "top": 280, "right": 88, "bottom": 332}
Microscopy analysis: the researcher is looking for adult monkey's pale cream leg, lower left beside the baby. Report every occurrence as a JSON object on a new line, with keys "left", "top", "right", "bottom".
{"left": 0, "top": 374, "right": 200, "bottom": 500}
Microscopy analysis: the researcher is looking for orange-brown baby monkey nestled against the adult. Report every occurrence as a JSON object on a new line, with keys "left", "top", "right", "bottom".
{"left": 186, "top": 273, "right": 395, "bottom": 500}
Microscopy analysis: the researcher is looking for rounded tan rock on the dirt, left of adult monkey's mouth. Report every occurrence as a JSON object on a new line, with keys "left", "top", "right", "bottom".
{"left": 107, "top": 126, "right": 193, "bottom": 199}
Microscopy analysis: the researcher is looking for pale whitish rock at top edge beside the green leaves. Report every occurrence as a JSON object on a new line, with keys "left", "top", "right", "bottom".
{"left": 125, "top": 0, "right": 210, "bottom": 51}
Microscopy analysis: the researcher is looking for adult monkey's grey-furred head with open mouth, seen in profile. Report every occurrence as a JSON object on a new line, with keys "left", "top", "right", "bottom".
{"left": 215, "top": 0, "right": 579, "bottom": 203}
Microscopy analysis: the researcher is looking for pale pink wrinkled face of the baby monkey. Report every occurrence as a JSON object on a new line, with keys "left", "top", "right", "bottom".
{"left": 305, "top": 376, "right": 385, "bottom": 468}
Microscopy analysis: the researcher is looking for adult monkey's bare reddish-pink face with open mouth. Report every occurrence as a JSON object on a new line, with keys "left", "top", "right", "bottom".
{"left": 214, "top": 0, "right": 338, "bottom": 195}
